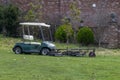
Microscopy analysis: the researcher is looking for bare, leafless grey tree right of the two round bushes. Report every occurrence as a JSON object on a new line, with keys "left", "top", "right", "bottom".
{"left": 93, "top": 0, "right": 109, "bottom": 47}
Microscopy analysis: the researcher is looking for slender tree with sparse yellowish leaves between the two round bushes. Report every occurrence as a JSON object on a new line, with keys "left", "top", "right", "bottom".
{"left": 69, "top": 0, "right": 80, "bottom": 42}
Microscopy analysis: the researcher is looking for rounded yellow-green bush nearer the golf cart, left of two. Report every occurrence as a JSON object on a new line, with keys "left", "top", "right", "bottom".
{"left": 55, "top": 24, "right": 73, "bottom": 42}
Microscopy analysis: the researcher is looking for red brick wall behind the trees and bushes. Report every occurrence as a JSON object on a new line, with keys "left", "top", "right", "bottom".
{"left": 0, "top": 0, "right": 120, "bottom": 46}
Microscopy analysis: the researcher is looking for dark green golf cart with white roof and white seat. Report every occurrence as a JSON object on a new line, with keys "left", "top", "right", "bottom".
{"left": 13, "top": 22, "right": 55, "bottom": 55}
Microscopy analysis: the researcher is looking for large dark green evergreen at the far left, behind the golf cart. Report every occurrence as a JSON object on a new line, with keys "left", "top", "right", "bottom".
{"left": 0, "top": 4, "right": 19, "bottom": 36}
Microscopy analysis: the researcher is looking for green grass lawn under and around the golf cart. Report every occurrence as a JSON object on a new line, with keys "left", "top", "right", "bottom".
{"left": 0, "top": 36, "right": 120, "bottom": 80}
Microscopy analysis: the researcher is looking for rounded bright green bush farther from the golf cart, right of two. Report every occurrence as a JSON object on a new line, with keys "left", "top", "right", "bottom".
{"left": 77, "top": 27, "right": 94, "bottom": 45}
